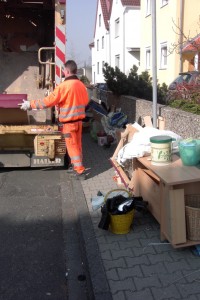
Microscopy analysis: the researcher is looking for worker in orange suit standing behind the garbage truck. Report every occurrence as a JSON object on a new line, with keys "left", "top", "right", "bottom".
{"left": 21, "top": 60, "right": 89, "bottom": 179}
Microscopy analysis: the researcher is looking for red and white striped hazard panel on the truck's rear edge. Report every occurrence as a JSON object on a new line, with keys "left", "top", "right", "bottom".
{"left": 55, "top": 25, "right": 66, "bottom": 85}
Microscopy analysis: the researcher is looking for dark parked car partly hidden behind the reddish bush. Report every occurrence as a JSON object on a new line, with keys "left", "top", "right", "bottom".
{"left": 167, "top": 71, "right": 200, "bottom": 101}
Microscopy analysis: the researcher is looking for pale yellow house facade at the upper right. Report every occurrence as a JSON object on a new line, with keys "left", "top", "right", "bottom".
{"left": 139, "top": 0, "right": 200, "bottom": 85}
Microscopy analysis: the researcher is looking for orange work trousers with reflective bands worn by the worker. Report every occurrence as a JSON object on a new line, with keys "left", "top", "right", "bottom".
{"left": 62, "top": 121, "right": 85, "bottom": 174}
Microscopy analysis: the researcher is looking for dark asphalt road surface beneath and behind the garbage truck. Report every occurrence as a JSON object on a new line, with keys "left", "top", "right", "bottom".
{"left": 0, "top": 168, "right": 92, "bottom": 300}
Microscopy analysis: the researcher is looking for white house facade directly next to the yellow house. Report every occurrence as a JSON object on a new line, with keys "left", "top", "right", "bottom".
{"left": 110, "top": 0, "right": 140, "bottom": 75}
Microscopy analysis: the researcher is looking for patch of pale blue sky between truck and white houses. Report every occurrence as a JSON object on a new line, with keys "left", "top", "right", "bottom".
{"left": 66, "top": 0, "right": 97, "bottom": 67}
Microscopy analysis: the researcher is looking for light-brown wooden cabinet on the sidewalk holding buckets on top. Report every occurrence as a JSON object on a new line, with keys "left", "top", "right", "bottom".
{"left": 134, "top": 155, "right": 200, "bottom": 248}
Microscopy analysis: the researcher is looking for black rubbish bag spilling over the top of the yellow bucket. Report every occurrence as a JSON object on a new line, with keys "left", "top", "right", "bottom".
{"left": 98, "top": 191, "right": 148, "bottom": 230}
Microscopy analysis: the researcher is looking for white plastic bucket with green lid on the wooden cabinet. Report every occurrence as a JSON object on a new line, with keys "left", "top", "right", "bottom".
{"left": 150, "top": 135, "right": 172, "bottom": 166}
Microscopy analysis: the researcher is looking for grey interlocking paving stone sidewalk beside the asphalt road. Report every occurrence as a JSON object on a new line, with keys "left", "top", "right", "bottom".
{"left": 81, "top": 132, "right": 200, "bottom": 300}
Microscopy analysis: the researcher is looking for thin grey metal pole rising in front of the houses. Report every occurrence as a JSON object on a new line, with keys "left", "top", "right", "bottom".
{"left": 151, "top": 0, "right": 157, "bottom": 128}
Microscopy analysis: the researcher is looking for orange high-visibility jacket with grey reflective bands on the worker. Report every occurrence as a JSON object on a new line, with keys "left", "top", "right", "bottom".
{"left": 30, "top": 75, "right": 89, "bottom": 123}
